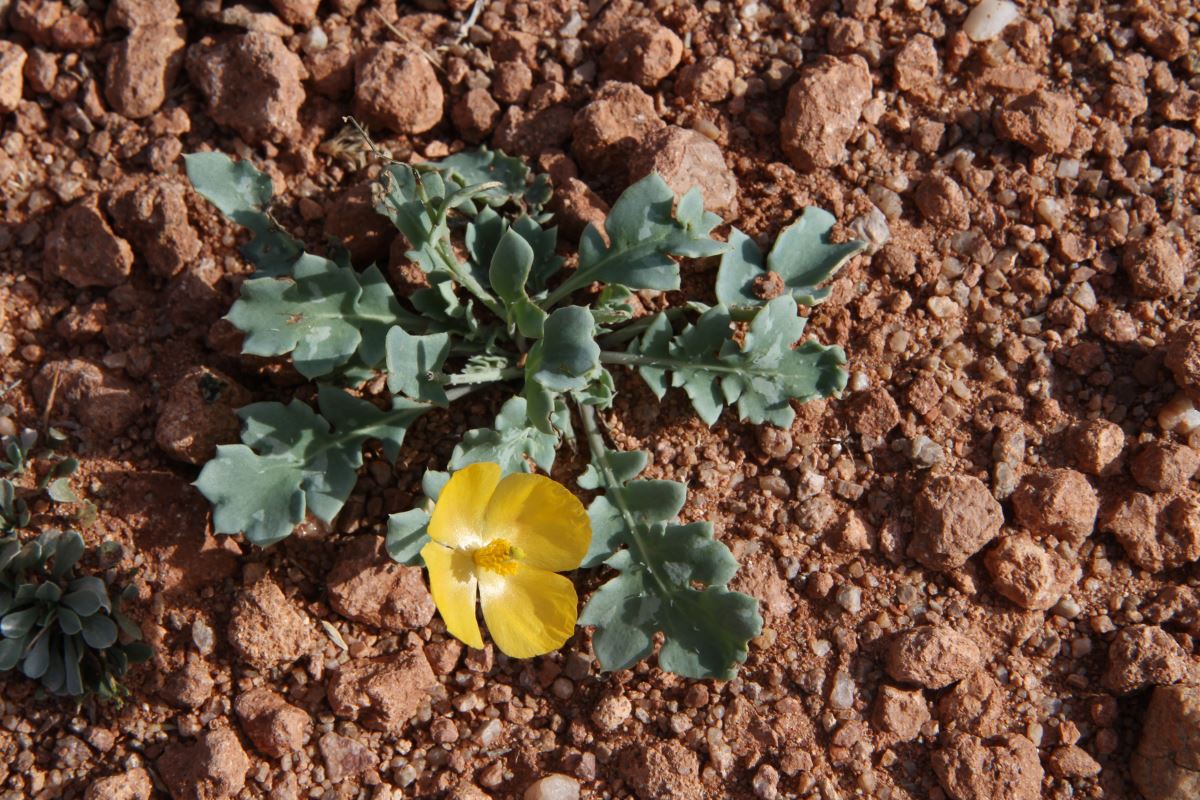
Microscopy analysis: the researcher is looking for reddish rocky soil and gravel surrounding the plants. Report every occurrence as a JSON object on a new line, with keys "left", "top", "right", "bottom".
{"left": 0, "top": 0, "right": 1200, "bottom": 800}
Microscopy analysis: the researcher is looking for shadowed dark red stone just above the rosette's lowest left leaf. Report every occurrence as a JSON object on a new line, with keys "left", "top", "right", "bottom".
{"left": 155, "top": 367, "right": 251, "bottom": 464}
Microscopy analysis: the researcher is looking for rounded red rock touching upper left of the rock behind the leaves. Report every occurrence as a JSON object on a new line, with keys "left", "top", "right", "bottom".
{"left": 571, "top": 83, "right": 666, "bottom": 176}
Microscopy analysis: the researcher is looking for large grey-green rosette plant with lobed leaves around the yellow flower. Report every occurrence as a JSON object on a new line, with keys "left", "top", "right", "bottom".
{"left": 187, "top": 140, "right": 863, "bottom": 678}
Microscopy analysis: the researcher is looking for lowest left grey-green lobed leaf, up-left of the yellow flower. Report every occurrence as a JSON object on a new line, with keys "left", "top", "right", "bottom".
{"left": 194, "top": 386, "right": 431, "bottom": 547}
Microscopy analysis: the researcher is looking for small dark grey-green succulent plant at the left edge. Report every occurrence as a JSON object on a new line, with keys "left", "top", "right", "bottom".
{"left": 0, "top": 530, "right": 150, "bottom": 699}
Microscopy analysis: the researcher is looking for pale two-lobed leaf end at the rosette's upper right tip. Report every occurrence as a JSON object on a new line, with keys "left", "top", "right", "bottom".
{"left": 716, "top": 206, "right": 866, "bottom": 308}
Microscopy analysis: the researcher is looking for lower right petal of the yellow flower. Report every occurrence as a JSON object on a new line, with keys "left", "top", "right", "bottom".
{"left": 479, "top": 564, "right": 578, "bottom": 658}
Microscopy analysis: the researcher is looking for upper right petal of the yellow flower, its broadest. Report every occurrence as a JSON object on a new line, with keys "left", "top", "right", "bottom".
{"left": 484, "top": 473, "right": 592, "bottom": 572}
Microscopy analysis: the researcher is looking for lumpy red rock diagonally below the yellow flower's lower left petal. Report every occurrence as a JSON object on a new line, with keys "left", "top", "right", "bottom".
{"left": 325, "top": 648, "right": 438, "bottom": 734}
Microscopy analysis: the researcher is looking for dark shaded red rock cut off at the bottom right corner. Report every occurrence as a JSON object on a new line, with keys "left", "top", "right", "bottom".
{"left": 1129, "top": 686, "right": 1200, "bottom": 800}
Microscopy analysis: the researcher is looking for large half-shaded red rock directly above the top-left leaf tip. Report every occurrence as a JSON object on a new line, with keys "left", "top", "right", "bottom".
{"left": 187, "top": 31, "right": 306, "bottom": 144}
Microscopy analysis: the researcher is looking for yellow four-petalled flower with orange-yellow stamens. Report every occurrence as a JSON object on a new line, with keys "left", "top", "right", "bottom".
{"left": 421, "top": 463, "right": 592, "bottom": 658}
